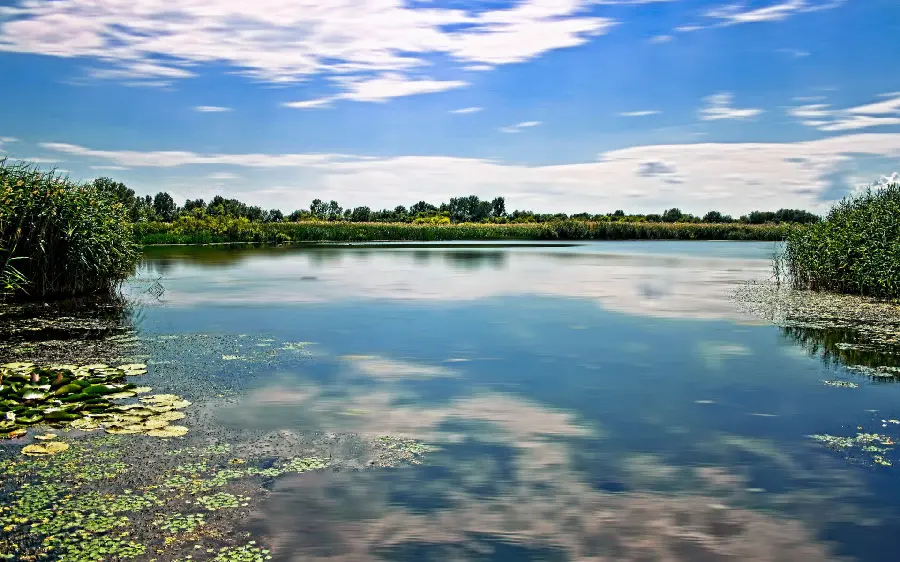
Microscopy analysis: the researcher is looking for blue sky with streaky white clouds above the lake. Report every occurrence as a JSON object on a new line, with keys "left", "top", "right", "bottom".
{"left": 0, "top": 0, "right": 900, "bottom": 214}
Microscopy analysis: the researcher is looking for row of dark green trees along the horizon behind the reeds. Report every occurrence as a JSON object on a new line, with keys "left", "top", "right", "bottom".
{"left": 93, "top": 177, "right": 820, "bottom": 224}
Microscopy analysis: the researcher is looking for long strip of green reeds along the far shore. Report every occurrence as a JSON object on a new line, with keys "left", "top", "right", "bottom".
{"left": 135, "top": 219, "right": 791, "bottom": 245}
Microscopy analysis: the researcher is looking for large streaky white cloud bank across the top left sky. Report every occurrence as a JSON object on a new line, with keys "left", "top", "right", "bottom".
{"left": 0, "top": 0, "right": 616, "bottom": 101}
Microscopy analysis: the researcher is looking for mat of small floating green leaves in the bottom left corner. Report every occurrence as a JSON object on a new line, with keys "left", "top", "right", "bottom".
{"left": 0, "top": 435, "right": 338, "bottom": 562}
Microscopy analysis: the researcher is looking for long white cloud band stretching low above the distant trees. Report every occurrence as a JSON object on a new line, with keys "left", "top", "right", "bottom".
{"left": 42, "top": 133, "right": 900, "bottom": 214}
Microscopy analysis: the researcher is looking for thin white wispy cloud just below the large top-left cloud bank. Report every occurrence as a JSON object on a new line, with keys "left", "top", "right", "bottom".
{"left": 284, "top": 72, "right": 468, "bottom": 109}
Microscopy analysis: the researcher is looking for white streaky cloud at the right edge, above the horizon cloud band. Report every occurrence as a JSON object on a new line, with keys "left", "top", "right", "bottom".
{"left": 788, "top": 92, "right": 900, "bottom": 132}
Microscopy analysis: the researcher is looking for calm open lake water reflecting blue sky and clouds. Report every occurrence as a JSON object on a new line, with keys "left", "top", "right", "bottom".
{"left": 130, "top": 242, "right": 900, "bottom": 561}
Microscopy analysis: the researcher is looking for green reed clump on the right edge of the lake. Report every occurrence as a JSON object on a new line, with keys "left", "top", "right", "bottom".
{"left": 783, "top": 184, "right": 900, "bottom": 298}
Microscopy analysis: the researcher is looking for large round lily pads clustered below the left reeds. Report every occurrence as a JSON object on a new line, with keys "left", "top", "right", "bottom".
{"left": 0, "top": 363, "right": 191, "bottom": 442}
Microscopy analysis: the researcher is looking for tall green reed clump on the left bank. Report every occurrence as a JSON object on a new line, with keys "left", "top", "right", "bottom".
{"left": 0, "top": 160, "right": 138, "bottom": 297}
